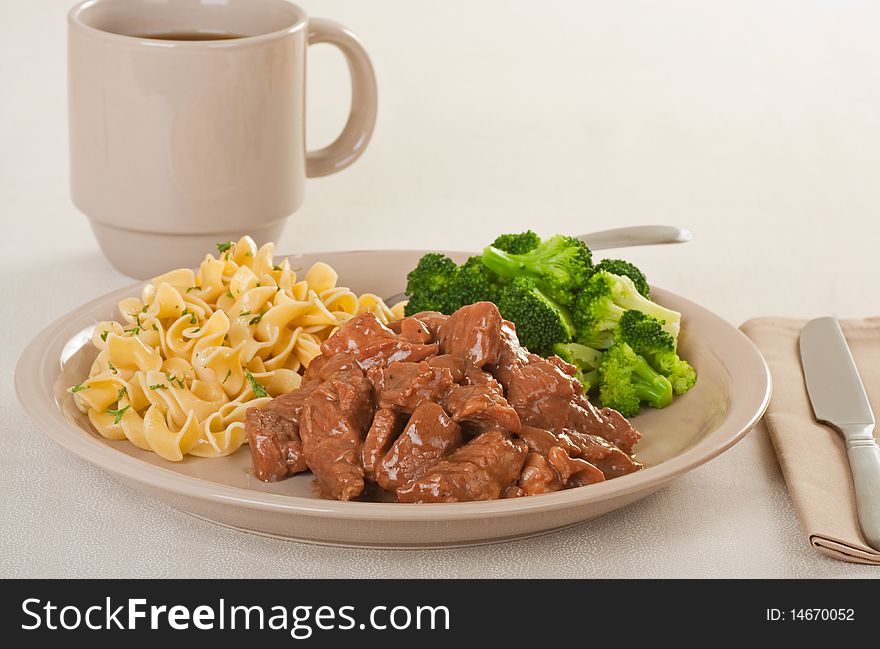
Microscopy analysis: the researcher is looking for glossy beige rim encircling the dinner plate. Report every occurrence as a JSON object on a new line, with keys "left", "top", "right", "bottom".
{"left": 15, "top": 249, "right": 772, "bottom": 522}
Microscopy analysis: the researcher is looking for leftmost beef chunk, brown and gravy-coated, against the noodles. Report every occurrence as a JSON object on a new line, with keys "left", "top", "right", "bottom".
{"left": 244, "top": 386, "right": 314, "bottom": 482}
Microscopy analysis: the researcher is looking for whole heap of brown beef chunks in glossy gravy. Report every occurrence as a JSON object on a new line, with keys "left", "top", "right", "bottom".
{"left": 245, "top": 302, "right": 642, "bottom": 502}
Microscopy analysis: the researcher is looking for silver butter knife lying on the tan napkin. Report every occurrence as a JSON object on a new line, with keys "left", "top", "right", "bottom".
{"left": 800, "top": 318, "right": 880, "bottom": 550}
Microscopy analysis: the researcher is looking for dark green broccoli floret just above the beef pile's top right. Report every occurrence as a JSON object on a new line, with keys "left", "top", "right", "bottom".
{"left": 498, "top": 277, "right": 573, "bottom": 356}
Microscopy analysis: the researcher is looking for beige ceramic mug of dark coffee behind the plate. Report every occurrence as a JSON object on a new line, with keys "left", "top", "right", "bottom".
{"left": 68, "top": 0, "right": 376, "bottom": 278}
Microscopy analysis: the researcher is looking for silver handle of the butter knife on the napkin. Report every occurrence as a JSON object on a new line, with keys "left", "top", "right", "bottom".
{"left": 846, "top": 426, "right": 880, "bottom": 550}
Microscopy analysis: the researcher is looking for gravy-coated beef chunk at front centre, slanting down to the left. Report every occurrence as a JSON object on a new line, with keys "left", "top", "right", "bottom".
{"left": 376, "top": 401, "right": 461, "bottom": 490}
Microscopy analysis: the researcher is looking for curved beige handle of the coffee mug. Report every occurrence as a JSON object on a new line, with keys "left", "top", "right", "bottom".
{"left": 306, "top": 18, "right": 377, "bottom": 178}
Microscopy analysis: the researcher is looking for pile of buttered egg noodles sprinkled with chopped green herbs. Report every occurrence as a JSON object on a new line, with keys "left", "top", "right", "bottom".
{"left": 69, "top": 237, "right": 404, "bottom": 461}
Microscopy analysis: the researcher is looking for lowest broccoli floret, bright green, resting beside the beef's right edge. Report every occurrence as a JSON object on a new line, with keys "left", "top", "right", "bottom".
{"left": 599, "top": 343, "right": 672, "bottom": 417}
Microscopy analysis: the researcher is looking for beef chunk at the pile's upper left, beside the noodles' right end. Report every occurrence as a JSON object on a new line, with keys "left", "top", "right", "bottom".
{"left": 321, "top": 313, "right": 439, "bottom": 370}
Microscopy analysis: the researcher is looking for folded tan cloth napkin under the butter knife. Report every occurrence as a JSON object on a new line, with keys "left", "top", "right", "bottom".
{"left": 742, "top": 318, "right": 880, "bottom": 565}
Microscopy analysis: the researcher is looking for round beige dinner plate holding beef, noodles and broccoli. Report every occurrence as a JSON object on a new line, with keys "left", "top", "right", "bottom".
{"left": 15, "top": 250, "right": 770, "bottom": 548}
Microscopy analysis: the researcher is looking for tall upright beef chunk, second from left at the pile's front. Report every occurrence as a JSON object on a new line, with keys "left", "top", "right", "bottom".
{"left": 300, "top": 368, "right": 373, "bottom": 500}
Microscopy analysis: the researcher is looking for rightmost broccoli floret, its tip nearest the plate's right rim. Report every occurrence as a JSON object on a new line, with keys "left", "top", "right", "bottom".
{"left": 615, "top": 311, "right": 697, "bottom": 395}
